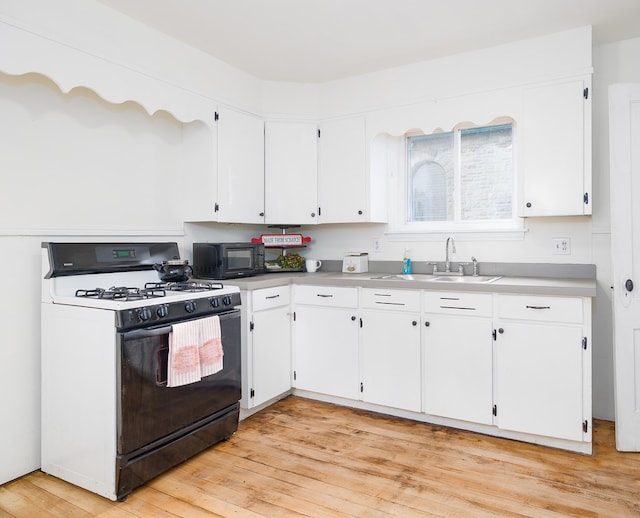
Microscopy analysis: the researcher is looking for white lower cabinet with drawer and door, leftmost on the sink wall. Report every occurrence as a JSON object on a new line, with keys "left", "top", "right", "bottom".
{"left": 293, "top": 286, "right": 359, "bottom": 399}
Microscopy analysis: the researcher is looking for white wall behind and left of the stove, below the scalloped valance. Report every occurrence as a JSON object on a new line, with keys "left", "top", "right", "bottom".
{"left": 0, "top": 69, "right": 198, "bottom": 482}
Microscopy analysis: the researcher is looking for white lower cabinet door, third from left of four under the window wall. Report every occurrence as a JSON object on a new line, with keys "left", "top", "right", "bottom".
{"left": 422, "top": 314, "right": 493, "bottom": 424}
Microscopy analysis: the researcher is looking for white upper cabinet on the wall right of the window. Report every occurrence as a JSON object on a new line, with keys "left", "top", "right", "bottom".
{"left": 518, "top": 76, "right": 592, "bottom": 217}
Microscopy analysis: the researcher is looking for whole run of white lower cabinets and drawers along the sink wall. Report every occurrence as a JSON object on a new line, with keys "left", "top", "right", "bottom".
{"left": 288, "top": 286, "right": 592, "bottom": 453}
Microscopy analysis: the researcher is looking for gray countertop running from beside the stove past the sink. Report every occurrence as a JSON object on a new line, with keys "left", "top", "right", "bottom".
{"left": 215, "top": 272, "right": 596, "bottom": 297}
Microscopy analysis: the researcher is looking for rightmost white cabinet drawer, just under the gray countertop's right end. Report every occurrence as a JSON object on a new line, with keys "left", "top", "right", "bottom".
{"left": 496, "top": 295, "right": 582, "bottom": 324}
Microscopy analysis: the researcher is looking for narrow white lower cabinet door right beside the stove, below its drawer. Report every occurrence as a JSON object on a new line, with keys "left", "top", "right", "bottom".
{"left": 252, "top": 305, "right": 292, "bottom": 406}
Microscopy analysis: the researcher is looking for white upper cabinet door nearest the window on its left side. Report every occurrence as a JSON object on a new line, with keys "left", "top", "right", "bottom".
{"left": 318, "top": 117, "right": 371, "bottom": 223}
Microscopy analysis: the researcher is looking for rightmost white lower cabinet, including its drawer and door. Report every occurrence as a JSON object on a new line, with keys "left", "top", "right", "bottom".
{"left": 495, "top": 295, "right": 591, "bottom": 441}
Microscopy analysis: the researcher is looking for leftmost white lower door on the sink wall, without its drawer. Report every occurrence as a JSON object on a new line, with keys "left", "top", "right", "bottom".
{"left": 294, "top": 306, "right": 359, "bottom": 399}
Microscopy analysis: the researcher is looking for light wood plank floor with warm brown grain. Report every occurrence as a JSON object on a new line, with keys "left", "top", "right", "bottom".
{"left": 0, "top": 397, "right": 640, "bottom": 518}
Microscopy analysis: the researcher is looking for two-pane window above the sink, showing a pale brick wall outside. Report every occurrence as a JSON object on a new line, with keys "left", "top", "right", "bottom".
{"left": 404, "top": 122, "right": 518, "bottom": 231}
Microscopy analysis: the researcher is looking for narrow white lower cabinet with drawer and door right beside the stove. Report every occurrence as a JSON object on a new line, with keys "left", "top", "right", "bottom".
{"left": 242, "top": 285, "right": 292, "bottom": 408}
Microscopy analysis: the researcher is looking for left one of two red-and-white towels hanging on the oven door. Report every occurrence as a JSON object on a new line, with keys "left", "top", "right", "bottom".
{"left": 167, "top": 320, "right": 201, "bottom": 387}
